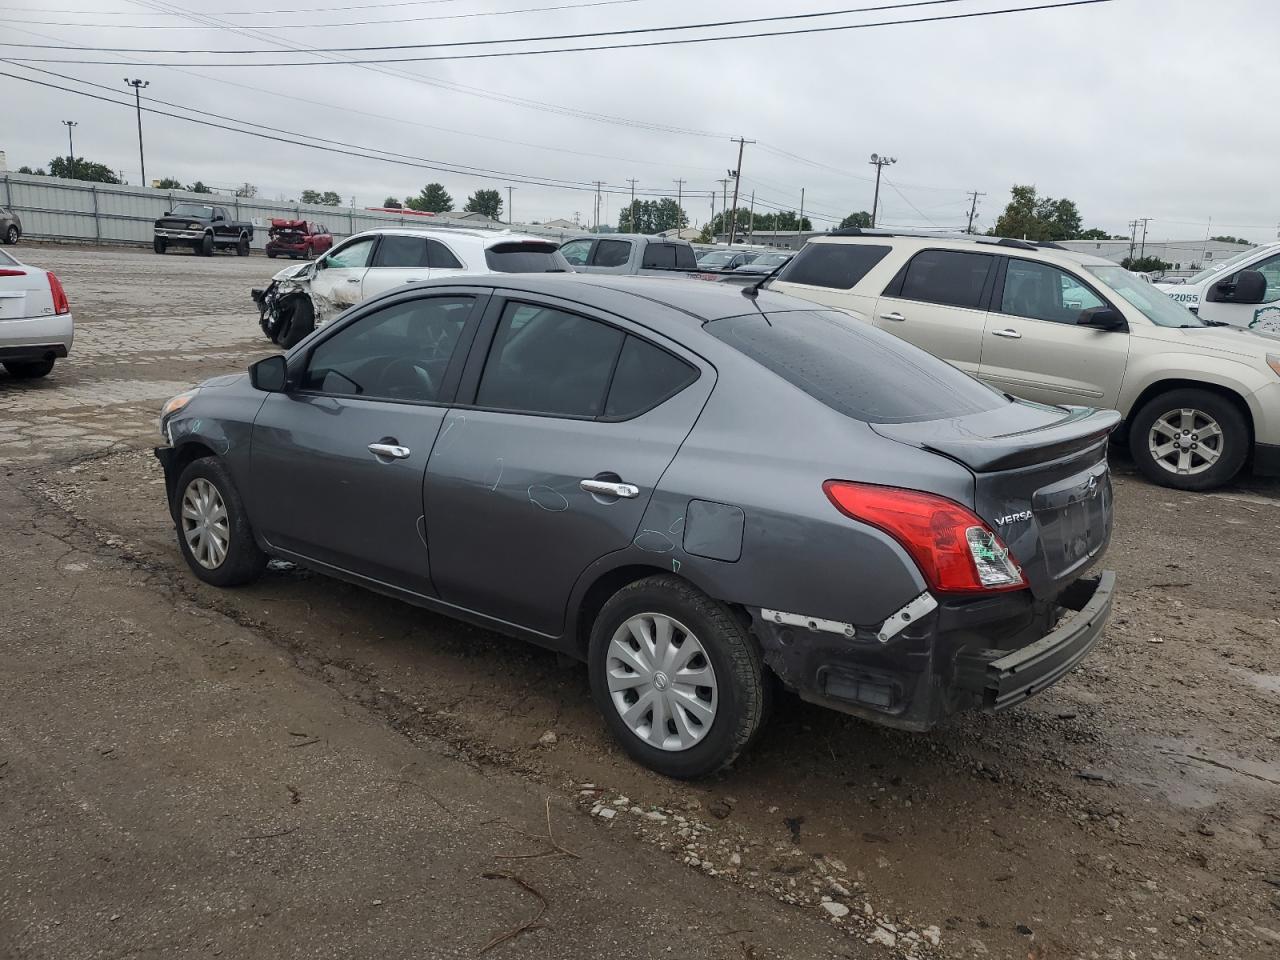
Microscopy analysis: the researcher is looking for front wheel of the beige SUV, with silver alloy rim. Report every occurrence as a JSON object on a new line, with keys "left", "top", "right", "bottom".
{"left": 1129, "top": 388, "right": 1251, "bottom": 490}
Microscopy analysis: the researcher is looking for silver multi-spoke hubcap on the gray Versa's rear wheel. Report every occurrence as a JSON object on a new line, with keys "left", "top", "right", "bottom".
{"left": 604, "top": 613, "right": 719, "bottom": 751}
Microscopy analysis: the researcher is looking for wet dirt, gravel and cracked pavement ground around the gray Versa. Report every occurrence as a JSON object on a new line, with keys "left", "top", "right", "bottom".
{"left": 0, "top": 246, "right": 1280, "bottom": 960}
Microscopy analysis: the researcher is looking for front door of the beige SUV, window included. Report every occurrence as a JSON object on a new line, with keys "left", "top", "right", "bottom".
{"left": 979, "top": 257, "right": 1129, "bottom": 407}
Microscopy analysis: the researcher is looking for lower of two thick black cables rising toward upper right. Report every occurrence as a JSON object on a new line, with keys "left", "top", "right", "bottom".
{"left": 2, "top": 0, "right": 1112, "bottom": 69}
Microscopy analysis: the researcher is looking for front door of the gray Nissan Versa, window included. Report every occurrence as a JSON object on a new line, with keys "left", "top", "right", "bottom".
{"left": 247, "top": 289, "right": 488, "bottom": 595}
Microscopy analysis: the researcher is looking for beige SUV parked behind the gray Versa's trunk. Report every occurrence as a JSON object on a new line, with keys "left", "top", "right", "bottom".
{"left": 769, "top": 230, "right": 1280, "bottom": 490}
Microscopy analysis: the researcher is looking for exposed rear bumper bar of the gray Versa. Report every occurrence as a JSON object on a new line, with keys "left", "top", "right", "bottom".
{"left": 956, "top": 570, "right": 1116, "bottom": 710}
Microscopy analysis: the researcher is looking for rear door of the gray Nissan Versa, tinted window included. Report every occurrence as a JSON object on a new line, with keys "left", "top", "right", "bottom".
{"left": 426, "top": 294, "right": 714, "bottom": 636}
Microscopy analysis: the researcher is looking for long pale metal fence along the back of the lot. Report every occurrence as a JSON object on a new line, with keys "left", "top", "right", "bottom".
{"left": 0, "top": 173, "right": 575, "bottom": 250}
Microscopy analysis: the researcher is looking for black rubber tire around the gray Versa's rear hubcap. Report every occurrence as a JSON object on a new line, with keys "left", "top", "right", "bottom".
{"left": 588, "top": 577, "right": 763, "bottom": 780}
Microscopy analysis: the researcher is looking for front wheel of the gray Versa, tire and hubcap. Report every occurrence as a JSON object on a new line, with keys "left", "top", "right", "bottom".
{"left": 174, "top": 457, "right": 266, "bottom": 586}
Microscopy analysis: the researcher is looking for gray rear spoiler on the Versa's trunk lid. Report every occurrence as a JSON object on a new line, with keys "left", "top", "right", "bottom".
{"left": 870, "top": 407, "right": 1121, "bottom": 474}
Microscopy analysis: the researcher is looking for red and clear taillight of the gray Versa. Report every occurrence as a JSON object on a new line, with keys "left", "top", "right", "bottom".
{"left": 822, "top": 480, "right": 1027, "bottom": 594}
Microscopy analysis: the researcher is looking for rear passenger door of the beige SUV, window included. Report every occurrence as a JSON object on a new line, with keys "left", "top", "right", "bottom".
{"left": 872, "top": 250, "right": 996, "bottom": 375}
